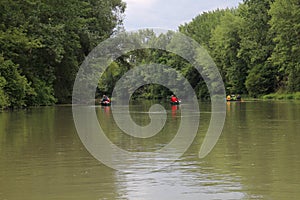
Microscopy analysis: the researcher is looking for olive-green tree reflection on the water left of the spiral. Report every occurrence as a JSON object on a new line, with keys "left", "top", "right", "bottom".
{"left": 0, "top": 106, "right": 118, "bottom": 199}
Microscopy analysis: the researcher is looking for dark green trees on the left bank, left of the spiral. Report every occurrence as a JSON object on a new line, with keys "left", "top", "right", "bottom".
{"left": 0, "top": 0, "right": 125, "bottom": 107}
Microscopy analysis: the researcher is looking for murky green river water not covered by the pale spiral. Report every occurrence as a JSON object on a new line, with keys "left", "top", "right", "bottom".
{"left": 0, "top": 102, "right": 300, "bottom": 200}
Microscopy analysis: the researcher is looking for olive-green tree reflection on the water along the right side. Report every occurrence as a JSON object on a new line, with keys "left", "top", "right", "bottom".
{"left": 209, "top": 102, "right": 300, "bottom": 199}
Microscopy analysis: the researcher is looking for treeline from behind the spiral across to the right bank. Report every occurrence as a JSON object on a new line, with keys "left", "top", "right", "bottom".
{"left": 99, "top": 0, "right": 300, "bottom": 98}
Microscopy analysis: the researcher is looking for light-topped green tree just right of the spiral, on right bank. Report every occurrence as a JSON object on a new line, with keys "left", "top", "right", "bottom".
{"left": 210, "top": 12, "right": 248, "bottom": 94}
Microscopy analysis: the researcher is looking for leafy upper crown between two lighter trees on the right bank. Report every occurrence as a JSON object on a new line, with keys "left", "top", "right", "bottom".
{"left": 238, "top": 0, "right": 274, "bottom": 65}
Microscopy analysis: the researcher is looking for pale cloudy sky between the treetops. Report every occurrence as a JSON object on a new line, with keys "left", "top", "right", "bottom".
{"left": 123, "top": 0, "right": 243, "bottom": 31}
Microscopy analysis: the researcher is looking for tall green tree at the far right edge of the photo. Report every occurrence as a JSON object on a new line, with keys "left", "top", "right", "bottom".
{"left": 269, "top": 0, "right": 300, "bottom": 92}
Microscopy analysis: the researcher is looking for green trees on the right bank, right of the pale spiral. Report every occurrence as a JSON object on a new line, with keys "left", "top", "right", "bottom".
{"left": 179, "top": 0, "right": 300, "bottom": 96}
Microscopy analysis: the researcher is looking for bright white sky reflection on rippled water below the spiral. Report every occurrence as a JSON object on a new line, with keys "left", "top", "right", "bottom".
{"left": 118, "top": 162, "right": 245, "bottom": 200}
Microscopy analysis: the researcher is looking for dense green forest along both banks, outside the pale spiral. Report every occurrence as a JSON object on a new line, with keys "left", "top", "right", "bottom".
{"left": 0, "top": 0, "right": 300, "bottom": 108}
